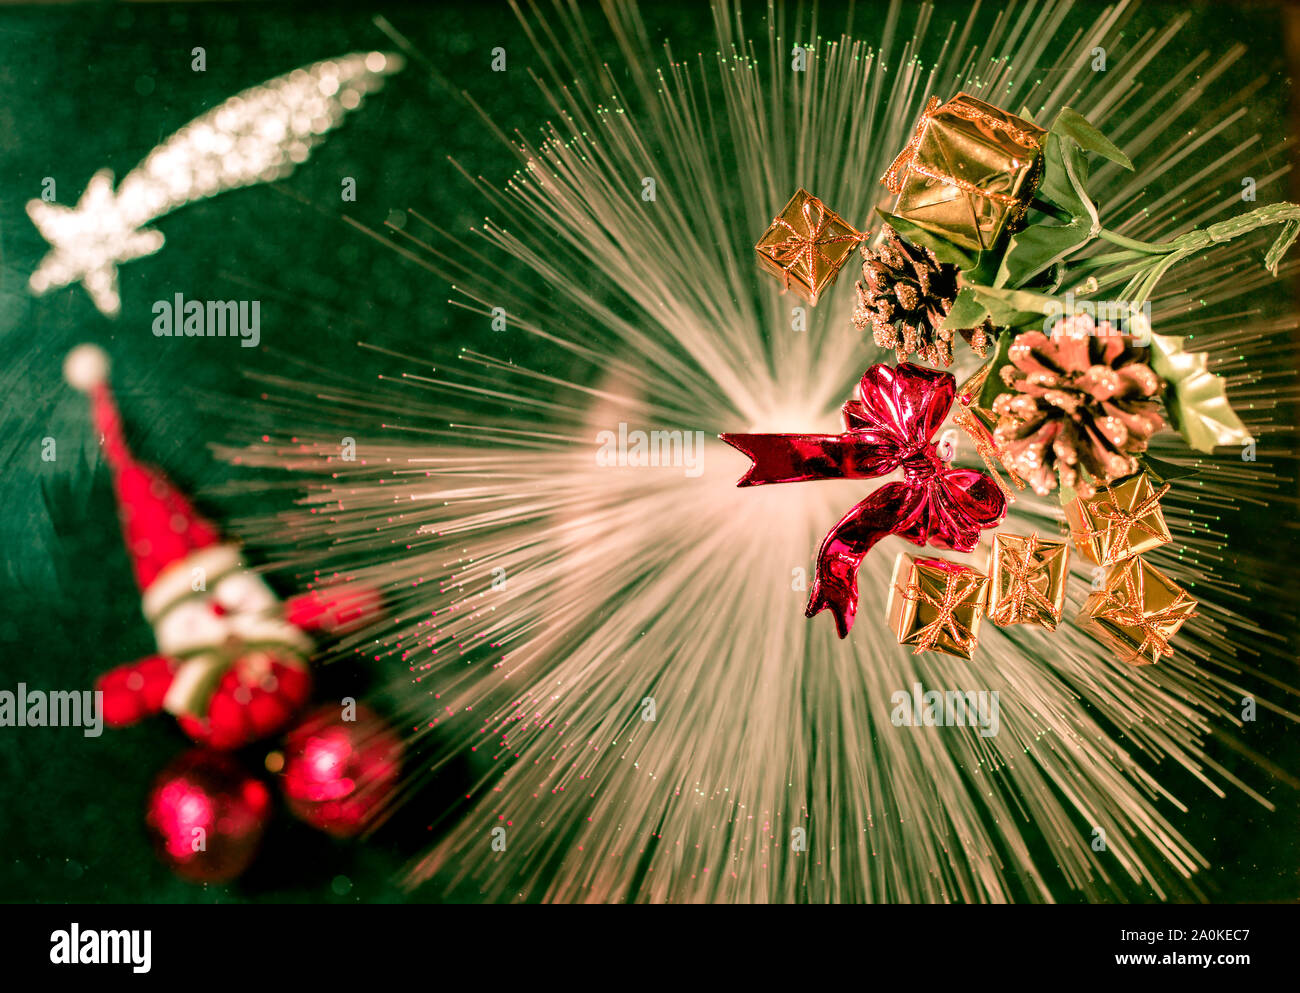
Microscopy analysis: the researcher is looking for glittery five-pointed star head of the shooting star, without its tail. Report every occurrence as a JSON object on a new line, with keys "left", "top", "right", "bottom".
{"left": 27, "top": 169, "right": 163, "bottom": 317}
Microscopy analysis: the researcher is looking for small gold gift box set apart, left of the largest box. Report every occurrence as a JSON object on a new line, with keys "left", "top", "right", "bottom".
{"left": 754, "top": 190, "right": 863, "bottom": 304}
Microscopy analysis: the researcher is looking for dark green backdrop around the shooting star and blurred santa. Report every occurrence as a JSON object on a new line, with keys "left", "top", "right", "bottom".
{"left": 0, "top": 3, "right": 1300, "bottom": 902}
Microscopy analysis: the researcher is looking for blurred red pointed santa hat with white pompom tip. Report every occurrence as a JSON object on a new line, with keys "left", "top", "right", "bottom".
{"left": 64, "top": 344, "right": 222, "bottom": 591}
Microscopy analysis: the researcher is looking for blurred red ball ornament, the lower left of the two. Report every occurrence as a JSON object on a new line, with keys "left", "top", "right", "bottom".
{"left": 146, "top": 749, "right": 270, "bottom": 883}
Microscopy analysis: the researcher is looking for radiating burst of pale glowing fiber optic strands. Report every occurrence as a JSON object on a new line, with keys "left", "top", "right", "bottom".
{"left": 226, "top": 3, "right": 1296, "bottom": 902}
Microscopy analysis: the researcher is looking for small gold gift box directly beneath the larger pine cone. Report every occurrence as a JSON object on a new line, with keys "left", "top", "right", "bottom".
{"left": 1065, "top": 473, "right": 1170, "bottom": 565}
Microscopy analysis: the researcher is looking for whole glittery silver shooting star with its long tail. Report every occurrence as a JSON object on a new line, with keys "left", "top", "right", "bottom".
{"left": 27, "top": 52, "right": 403, "bottom": 317}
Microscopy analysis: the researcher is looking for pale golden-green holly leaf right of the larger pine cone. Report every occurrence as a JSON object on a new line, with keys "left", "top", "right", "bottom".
{"left": 1151, "top": 334, "right": 1251, "bottom": 452}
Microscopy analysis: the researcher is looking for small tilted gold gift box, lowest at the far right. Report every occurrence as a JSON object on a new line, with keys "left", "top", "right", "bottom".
{"left": 1079, "top": 556, "right": 1196, "bottom": 665}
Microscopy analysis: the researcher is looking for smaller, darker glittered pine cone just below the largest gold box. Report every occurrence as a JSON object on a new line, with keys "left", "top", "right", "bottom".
{"left": 853, "top": 225, "right": 993, "bottom": 365}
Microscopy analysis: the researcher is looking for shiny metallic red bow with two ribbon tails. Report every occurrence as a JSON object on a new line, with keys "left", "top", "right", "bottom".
{"left": 720, "top": 363, "right": 1006, "bottom": 638}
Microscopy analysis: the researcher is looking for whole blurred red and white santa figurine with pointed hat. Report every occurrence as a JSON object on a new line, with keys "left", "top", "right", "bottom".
{"left": 64, "top": 344, "right": 380, "bottom": 749}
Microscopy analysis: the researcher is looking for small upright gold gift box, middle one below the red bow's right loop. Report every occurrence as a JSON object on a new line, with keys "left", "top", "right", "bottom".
{"left": 988, "top": 533, "right": 1070, "bottom": 630}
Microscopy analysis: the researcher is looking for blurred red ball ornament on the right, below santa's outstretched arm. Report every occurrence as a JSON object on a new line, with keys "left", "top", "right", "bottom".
{"left": 281, "top": 707, "right": 402, "bottom": 838}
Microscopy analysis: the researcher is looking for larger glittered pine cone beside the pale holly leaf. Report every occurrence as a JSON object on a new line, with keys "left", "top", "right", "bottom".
{"left": 993, "top": 316, "right": 1165, "bottom": 497}
